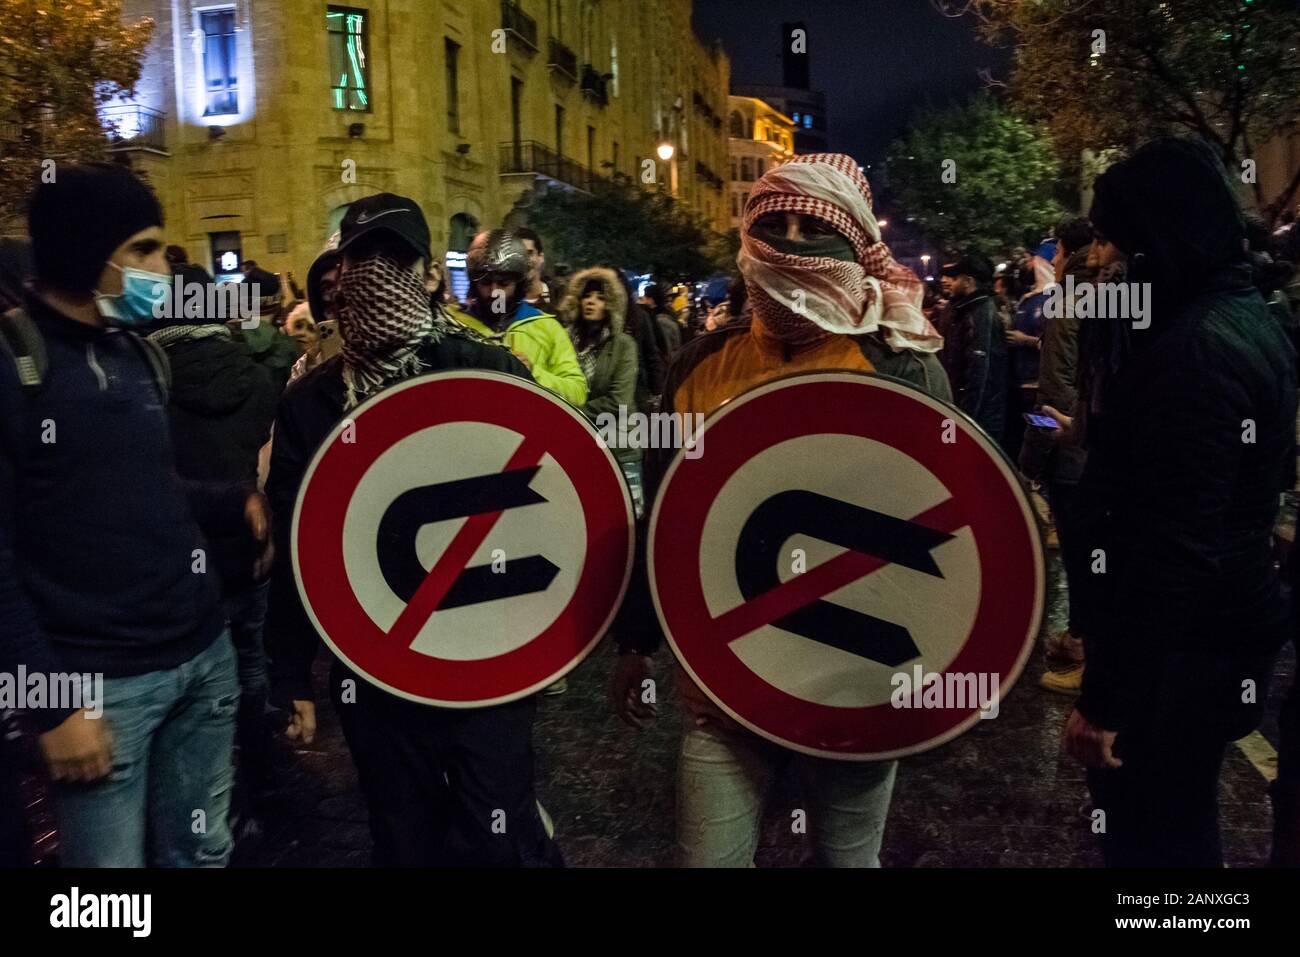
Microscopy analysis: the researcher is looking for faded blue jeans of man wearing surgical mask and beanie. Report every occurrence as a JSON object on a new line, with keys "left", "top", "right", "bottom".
{"left": 57, "top": 629, "right": 239, "bottom": 867}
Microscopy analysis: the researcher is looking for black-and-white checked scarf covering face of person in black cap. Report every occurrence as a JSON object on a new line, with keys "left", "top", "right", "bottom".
{"left": 338, "top": 256, "right": 446, "bottom": 408}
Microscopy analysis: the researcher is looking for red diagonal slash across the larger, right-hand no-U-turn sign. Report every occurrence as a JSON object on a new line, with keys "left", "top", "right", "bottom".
{"left": 712, "top": 498, "right": 969, "bottom": 644}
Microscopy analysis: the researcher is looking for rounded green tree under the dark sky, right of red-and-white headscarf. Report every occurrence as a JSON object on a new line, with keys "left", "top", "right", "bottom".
{"left": 887, "top": 94, "right": 1065, "bottom": 255}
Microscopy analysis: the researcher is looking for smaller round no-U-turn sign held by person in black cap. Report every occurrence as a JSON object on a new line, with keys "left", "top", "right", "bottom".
{"left": 291, "top": 371, "right": 633, "bottom": 707}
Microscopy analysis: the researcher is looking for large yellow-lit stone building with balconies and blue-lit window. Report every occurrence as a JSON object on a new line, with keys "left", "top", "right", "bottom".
{"left": 113, "top": 0, "right": 731, "bottom": 277}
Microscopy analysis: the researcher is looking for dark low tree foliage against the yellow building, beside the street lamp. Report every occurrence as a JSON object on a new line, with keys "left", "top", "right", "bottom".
{"left": 528, "top": 177, "right": 735, "bottom": 280}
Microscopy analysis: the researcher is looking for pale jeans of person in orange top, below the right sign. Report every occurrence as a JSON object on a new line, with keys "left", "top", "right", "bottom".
{"left": 677, "top": 726, "right": 898, "bottom": 867}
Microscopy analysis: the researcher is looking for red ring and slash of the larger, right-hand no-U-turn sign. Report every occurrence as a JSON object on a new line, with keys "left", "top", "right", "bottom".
{"left": 647, "top": 372, "right": 1044, "bottom": 761}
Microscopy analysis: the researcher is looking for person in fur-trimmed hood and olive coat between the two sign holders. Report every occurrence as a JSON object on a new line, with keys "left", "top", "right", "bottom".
{"left": 559, "top": 268, "right": 641, "bottom": 462}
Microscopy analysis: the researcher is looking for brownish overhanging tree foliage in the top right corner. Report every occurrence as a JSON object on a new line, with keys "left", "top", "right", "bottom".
{"left": 936, "top": 0, "right": 1300, "bottom": 217}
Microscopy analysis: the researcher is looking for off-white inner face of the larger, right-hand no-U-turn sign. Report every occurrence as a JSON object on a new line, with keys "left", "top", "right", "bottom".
{"left": 699, "top": 433, "right": 980, "bottom": 707}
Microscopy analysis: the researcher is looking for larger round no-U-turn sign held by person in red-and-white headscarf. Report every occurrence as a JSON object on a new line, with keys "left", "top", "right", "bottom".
{"left": 647, "top": 373, "right": 1044, "bottom": 761}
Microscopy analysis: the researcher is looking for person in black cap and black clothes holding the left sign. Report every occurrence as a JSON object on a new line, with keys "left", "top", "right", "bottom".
{"left": 267, "top": 194, "right": 560, "bottom": 866}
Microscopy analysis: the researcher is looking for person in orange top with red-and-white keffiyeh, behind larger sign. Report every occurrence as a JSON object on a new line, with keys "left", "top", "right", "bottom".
{"left": 612, "top": 153, "right": 952, "bottom": 866}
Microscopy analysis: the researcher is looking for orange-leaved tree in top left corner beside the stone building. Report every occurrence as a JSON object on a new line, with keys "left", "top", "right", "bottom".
{"left": 0, "top": 0, "right": 153, "bottom": 221}
